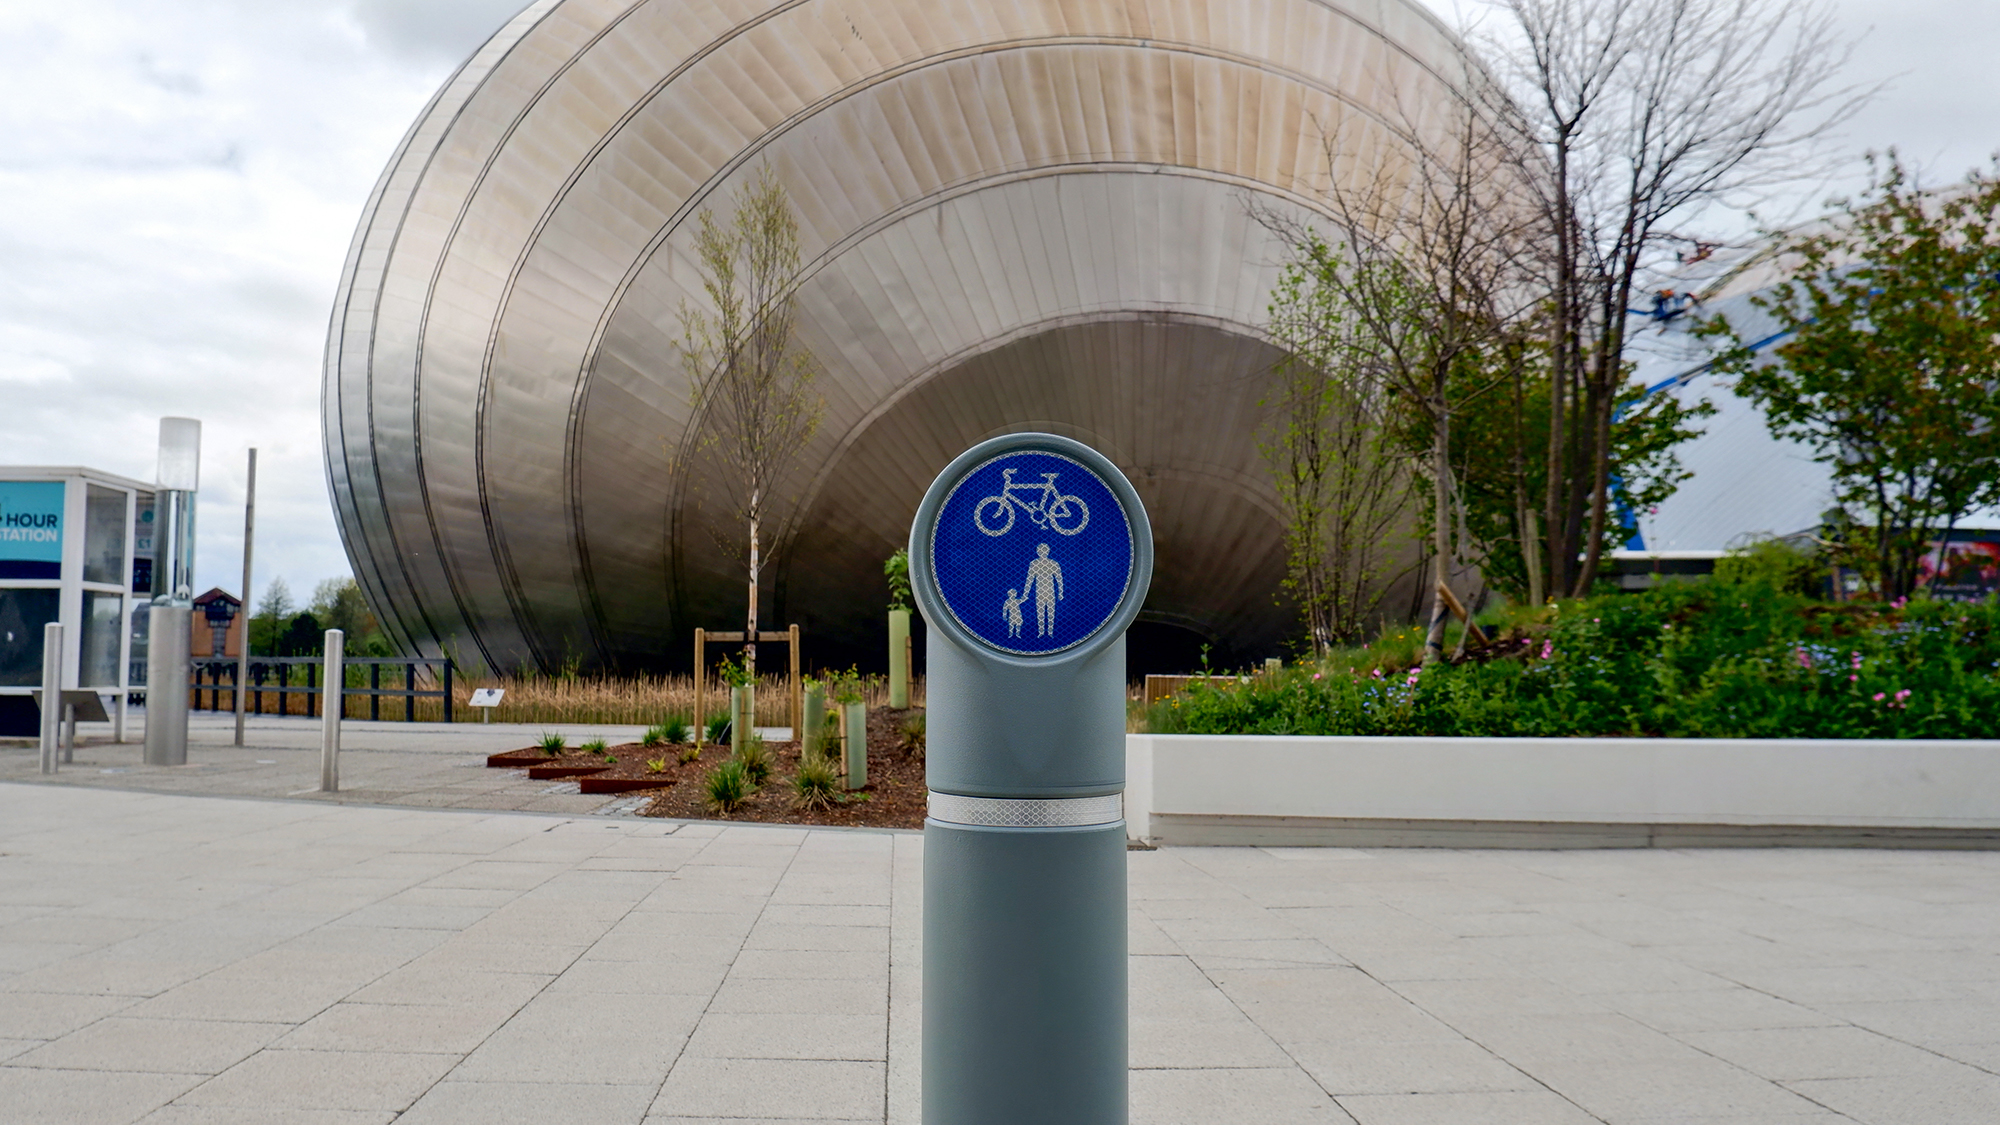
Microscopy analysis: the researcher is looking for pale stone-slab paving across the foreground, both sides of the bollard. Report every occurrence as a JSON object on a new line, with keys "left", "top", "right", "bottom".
{"left": 0, "top": 776, "right": 2000, "bottom": 1125}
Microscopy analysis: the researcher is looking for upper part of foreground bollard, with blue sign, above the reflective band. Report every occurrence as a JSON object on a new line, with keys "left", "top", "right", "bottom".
{"left": 910, "top": 434, "right": 1152, "bottom": 799}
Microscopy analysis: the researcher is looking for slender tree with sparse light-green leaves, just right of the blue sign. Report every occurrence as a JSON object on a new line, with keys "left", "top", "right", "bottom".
{"left": 1262, "top": 232, "right": 1414, "bottom": 657}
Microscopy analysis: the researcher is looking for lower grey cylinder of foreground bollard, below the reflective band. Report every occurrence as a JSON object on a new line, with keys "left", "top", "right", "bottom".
{"left": 924, "top": 821, "right": 1128, "bottom": 1125}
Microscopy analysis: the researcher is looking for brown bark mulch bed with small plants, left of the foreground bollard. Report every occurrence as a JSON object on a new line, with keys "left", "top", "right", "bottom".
{"left": 486, "top": 709, "right": 928, "bottom": 829}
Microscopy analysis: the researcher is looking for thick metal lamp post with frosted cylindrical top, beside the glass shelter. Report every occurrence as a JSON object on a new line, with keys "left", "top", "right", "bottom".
{"left": 146, "top": 418, "right": 202, "bottom": 765}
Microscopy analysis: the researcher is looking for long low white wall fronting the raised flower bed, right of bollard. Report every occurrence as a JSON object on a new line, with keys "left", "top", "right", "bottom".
{"left": 1126, "top": 735, "right": 2000, "bottom": 839}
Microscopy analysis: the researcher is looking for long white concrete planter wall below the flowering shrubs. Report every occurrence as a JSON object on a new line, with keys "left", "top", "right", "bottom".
{"left": 1126, "top": 735, "right": 2000, "bottom": 847}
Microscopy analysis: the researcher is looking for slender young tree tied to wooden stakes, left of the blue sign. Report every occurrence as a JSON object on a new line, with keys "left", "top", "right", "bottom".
{"left": 680, "top": 166, "right": 822, "bottom": 677}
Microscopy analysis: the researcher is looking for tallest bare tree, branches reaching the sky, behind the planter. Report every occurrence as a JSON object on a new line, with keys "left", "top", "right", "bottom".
{"left": 1490, "top": 0, "right": 1872, "bottom": 597}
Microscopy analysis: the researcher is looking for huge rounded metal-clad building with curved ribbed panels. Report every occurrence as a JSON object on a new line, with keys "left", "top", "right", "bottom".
{"left": 324, "top": 0, "right": 1468, "bottom": 669}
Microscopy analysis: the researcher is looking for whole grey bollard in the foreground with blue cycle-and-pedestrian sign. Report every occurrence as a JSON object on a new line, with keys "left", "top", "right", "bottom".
{"left": 910, "top": 434, "right": 1152, "bottom": 1125}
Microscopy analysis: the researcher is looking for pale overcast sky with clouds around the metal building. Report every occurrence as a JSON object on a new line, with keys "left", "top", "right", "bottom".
{"left": 0, "top": 0, "right": 2000, "bottom": 601}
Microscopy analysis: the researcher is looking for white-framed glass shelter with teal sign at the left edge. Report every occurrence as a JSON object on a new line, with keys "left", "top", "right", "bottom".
{"left": 0, "top": 464, "right": 154, "bottom": 741}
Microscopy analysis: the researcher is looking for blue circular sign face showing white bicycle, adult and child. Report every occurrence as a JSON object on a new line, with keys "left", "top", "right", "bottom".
{"left": 930, "top": 448, "right": 1136, "bottom": 657}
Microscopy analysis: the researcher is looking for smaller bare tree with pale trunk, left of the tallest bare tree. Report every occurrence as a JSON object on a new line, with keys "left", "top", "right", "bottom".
{"left": 1258, "top": 92, "right": 1542, "bottom": 663}
